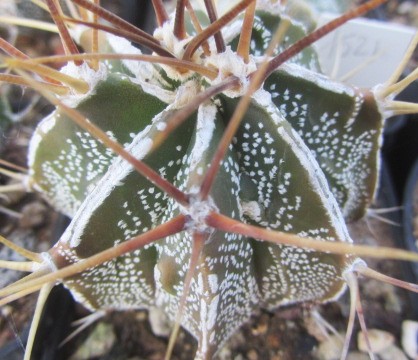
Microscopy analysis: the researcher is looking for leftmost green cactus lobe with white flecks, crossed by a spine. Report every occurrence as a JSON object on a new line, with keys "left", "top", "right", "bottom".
{"left": 29, "top": 74, "right": 165, "bottom": 217}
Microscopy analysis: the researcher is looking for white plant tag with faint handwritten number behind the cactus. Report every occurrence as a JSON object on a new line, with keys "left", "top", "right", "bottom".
{"left": 315, "top": 14, "right": 416, "bottom": 87}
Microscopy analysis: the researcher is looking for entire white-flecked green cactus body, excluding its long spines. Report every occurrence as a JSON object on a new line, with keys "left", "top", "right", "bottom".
{"left": 29, "top": 1, "right": 385, "bottom": 358}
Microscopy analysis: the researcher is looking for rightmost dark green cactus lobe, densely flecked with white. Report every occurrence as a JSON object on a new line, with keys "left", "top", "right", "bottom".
{"left": 264, "top": 66, "right": 384, "bottom": 221}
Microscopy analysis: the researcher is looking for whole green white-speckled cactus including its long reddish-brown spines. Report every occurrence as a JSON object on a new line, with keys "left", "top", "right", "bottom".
{"left": 0, "top": 0, "right": 417, "bottom": 358}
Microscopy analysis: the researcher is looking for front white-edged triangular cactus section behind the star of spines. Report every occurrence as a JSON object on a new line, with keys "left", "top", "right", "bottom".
{"left": 43, "top": 76, "right": 353, "bottom": 356}
